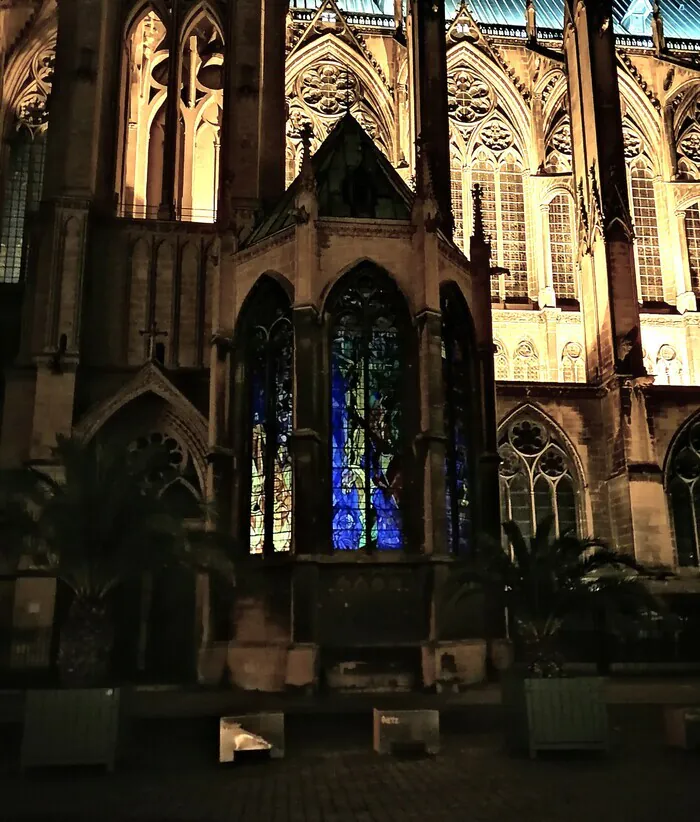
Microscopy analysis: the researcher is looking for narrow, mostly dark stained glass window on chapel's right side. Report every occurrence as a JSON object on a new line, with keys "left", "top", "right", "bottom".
{"left": 441, "top": 293, "right": 474, "bottom": 554}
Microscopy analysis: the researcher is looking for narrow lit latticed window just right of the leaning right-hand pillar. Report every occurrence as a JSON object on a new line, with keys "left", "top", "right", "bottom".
{"left": 629, "top": 159, "right": 664, "bottom": 302}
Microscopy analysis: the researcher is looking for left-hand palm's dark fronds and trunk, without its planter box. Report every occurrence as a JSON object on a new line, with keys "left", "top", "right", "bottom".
{"left": 0, "top": 438, "right": 233, "bottom": 685}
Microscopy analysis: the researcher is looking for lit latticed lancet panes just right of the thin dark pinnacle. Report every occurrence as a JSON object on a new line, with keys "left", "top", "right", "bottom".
{"left": 471, "top": 154, "right": 529, "bottom": 301}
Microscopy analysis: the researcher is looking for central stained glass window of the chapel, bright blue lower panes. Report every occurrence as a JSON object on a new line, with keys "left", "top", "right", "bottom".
{"left": 331, "top": 267, "right": 406, "bottom": 551}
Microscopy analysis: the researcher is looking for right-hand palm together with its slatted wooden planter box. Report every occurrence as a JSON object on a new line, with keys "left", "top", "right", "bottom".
{"left": 453, "top": 518, "right": 663, "bottom": 756}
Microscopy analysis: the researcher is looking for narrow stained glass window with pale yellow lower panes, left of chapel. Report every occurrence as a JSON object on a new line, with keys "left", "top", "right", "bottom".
{"left": 247, "top": 286, "right": 293, "bottom": 554}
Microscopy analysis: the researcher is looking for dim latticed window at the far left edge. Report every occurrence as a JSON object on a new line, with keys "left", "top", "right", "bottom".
{"left": 0, "top": 126, "right": 46, "bottom": 283}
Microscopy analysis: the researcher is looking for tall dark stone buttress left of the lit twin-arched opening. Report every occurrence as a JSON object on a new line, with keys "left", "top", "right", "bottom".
{"left": 0, "top": 0, "right": 120, "bottom": 461}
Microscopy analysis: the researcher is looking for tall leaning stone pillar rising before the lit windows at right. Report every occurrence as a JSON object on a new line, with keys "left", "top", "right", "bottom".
{"left": 564, "top": 0, "right": 645, "bottom": 379}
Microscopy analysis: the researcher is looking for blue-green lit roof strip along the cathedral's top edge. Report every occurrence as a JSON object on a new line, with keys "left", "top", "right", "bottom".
{"left": 291, "top": 0, "right": 700, "bottom": 40}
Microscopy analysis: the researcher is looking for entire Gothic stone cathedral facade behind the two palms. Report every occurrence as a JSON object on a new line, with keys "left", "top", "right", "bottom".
{"left": 0, "top": 0, "right": 700, "bottom": 690}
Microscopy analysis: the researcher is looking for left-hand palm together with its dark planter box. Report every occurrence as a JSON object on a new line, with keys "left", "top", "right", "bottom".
{"left": 0, "top": 438, "right": 233, "bottom": 767}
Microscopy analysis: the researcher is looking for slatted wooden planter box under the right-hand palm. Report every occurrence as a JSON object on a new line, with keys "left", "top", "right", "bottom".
{"left": 503, "top": 676, "right": 609, "bottom": 758}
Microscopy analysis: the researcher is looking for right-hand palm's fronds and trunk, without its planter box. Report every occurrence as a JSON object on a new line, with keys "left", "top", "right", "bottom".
{"left": 453, "top": 518, "right": 664, "bottom": 676}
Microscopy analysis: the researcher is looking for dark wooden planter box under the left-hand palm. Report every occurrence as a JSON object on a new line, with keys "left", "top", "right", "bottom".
{"left": 20, "top": 688, "right": 121, "bottom": 771}
